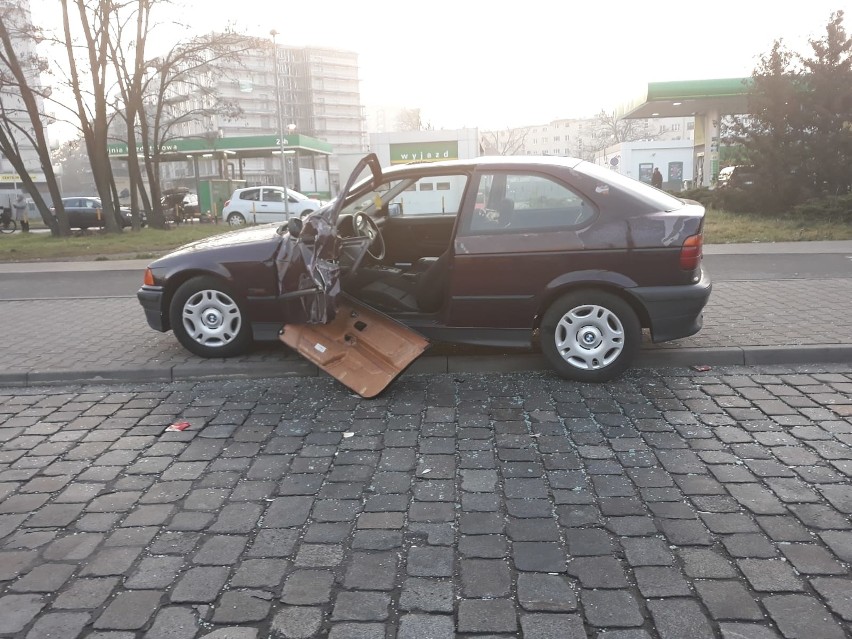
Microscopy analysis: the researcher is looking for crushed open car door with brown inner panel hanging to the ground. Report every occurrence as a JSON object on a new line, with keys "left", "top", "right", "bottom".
{"left": 276, "top": 154, "right": 428, "bottom": 397}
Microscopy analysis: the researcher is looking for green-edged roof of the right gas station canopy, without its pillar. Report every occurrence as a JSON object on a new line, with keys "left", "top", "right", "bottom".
{"left": 618, "top": 78, "right": 752, "bottom": 120}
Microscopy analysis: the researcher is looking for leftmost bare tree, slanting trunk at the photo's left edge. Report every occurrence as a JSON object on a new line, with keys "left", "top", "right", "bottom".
{"left": 0, "top": 3, "right": 70, "bottom": 235}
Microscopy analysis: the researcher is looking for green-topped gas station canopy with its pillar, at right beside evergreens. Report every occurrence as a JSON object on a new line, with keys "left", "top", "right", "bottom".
{"left": 617, "top": 78, "right": 752, "bottom": 186}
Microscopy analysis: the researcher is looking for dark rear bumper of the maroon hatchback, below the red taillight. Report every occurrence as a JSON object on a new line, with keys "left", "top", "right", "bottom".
{"left": 630, "top": 270, "right": 713, "bottom": 342}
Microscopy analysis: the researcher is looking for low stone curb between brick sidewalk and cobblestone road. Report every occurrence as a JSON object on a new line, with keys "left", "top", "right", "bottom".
{"left": 0, "top": 344, "right": 852, "bottom": 387}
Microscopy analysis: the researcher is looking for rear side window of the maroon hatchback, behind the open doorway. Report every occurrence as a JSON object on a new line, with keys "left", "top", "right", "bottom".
{"left": 469, "top": 173, "right": 597, "bottom": 234}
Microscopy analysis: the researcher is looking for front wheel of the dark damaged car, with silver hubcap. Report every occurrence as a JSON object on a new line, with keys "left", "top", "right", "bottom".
{"left": 169, "top": 276, "right": 252, "bottom": 357}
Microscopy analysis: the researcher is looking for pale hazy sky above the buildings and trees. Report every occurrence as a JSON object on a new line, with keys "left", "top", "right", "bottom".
{"left": 31, "top": 0, "right": 852, "bottom": 140}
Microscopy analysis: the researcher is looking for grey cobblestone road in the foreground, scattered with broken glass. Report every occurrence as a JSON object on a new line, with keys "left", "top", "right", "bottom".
{"left": 0, "top": 365, "right": 852, "bottom": 639}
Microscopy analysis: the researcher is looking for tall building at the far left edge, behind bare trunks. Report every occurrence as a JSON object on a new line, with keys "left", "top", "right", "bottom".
{"left": 0, "top": 0, "right": 47, "bottom": 206}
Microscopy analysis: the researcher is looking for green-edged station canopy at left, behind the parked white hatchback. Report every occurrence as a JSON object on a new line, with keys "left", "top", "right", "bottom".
{"left": 108, "top": 134, "right": 332, "bottom": 213}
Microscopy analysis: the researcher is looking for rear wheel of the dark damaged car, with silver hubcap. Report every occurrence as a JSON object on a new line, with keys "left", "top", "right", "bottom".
{"left": 540, "top": 289, "right": 642, "bottom": 382}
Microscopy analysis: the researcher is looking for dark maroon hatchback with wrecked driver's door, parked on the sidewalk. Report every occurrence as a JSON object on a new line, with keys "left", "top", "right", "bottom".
{"left": 138, "top": 155, "right": 711, "bottom": 394}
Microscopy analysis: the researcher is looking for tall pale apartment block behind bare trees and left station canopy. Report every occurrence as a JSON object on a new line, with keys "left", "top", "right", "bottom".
{"left": 161, "top": 42, "right": 367, "bottom": 190}
